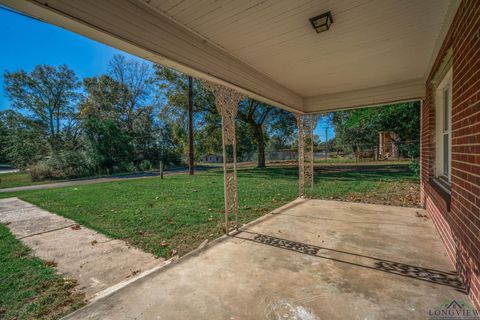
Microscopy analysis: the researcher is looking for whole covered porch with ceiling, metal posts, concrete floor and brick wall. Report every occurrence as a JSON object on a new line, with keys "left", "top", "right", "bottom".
{"left": 1, "top": 0, "right": 480, "bottom": 319}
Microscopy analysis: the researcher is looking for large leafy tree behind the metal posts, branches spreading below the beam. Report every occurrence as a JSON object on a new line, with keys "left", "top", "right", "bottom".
{"left": 155, "top": 66, "right": 295, "bottom": 168}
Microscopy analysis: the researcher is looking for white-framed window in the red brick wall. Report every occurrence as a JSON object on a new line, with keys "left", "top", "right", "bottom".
{"left": 435, "top": 68, "right": 452, "bottom": 184}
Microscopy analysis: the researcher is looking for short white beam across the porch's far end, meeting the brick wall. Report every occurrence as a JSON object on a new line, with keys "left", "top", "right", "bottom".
{"left": 303, "top": 79, "right": 425, "bottom": 113}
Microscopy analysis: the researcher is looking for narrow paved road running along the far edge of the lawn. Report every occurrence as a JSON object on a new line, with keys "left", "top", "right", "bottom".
{"left": 0, "top": 166, "right": 214, "bottom": 193}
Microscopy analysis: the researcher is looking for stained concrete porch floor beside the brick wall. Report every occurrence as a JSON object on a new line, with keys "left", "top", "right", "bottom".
{"left": 67, "top": 199, "right": 468, "bottom": 320}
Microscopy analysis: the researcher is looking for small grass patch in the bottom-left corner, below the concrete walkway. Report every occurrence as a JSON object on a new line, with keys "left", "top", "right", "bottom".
{"left": 0, "top": 224, "right": 83, "bottom": 319}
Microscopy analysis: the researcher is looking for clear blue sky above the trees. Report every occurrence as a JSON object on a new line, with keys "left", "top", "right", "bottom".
{"left": 0, "top": 7, "right": 334, "bottom": 141}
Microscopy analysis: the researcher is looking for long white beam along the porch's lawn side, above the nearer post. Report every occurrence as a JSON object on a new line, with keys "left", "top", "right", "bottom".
{"left": 0, "top": 0, "right": 303, "bottom": 113}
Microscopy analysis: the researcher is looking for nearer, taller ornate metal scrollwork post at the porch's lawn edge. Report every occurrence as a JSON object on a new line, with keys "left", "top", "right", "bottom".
{"left": 202, "top": 80, "right": 245, "bottom": 234}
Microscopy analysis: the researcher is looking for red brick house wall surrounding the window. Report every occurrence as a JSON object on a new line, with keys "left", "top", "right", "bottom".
{"left": 421, "top": 0, "right": 480, "bottom": 308}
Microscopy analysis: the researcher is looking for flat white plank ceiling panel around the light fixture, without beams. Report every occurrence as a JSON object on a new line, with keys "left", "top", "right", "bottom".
{"left": 144, "top": 0, "right": 449, "bottom": 97}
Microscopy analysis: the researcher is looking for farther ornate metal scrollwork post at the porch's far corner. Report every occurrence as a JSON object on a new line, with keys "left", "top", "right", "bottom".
{"left": 295, "top": 114, "right": 318, "bottom": 197}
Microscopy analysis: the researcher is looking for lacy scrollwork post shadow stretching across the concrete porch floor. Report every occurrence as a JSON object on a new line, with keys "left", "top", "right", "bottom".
{"left": 234, "top": 231, "right": 466, "bottom": 293}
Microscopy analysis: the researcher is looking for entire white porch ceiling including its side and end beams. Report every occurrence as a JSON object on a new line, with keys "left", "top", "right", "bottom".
{"left": 0, "top": 0, "right": 458, "bottom": 112}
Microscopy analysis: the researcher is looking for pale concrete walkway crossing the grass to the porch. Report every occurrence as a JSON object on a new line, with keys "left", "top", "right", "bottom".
{"left": 0, "top": 198, "right": 164, "bottom": 299}
